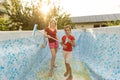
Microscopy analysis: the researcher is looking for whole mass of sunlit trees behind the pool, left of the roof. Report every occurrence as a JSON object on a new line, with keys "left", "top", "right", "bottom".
{"left": 3, "top": 0, "right": 72, "bottom": 30}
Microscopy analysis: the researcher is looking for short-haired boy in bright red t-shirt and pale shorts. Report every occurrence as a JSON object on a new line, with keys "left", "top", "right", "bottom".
{"left": 61, "top": 25, "right": 75, "bottom": 80}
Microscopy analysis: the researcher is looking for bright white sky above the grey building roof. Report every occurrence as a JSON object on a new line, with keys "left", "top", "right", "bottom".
{"left": 60, "top": 0, "right": 120, "bottom": 17}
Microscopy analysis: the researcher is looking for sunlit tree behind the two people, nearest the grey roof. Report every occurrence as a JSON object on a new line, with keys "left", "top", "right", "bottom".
{"left": 48, "top": 5, "right": 74, "bottom": 29}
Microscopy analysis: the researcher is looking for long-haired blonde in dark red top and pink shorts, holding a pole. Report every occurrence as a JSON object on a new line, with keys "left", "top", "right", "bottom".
{"left": 45, "top": 19, "right": 59, "bottom": 77}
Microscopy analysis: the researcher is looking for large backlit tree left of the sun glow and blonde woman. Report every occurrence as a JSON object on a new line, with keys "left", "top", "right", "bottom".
{"left": 3, "top": 0, "right": 44, "bottom": 30}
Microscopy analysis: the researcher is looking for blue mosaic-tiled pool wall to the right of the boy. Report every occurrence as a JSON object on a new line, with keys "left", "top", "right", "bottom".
{"left": 74, "top": 27, "right": 120, "bottom": 80}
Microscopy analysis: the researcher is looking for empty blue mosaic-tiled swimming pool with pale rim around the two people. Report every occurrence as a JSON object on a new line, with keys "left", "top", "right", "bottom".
{"left": 0, "top": 27, "right": 120, "bottom": 80}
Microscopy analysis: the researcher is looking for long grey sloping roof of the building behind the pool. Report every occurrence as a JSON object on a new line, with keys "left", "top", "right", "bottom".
{"left": 71, "top": 13, "right": 120, "bottom": 23}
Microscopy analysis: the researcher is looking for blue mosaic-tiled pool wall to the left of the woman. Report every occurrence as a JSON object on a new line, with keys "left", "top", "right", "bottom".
{"left": 0, "top": 36, "right": 48, "bottom": 80}
